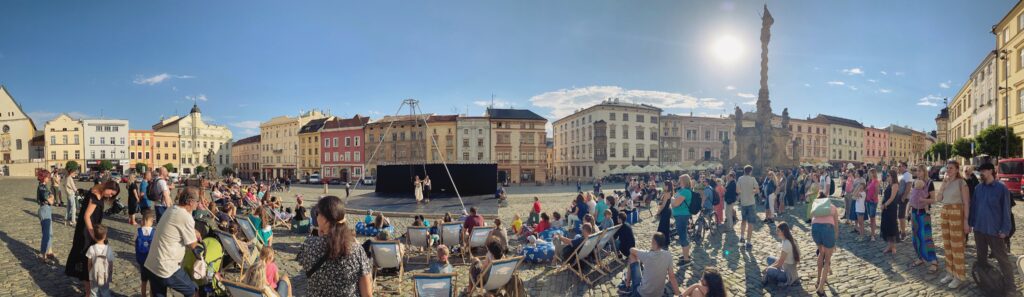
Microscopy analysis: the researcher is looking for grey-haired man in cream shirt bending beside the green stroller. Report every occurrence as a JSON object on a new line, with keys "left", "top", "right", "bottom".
{"left": 142, "top": 186, "right": 202, "bottom": 297}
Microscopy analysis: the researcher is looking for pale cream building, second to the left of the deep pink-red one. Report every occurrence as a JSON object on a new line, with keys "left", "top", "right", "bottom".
{"left": 259, "top": 110, "right": 327, "bottom": 180}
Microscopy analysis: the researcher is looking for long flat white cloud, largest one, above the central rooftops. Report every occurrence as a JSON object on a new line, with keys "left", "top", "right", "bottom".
{"left": 529, "top": 86, "right": 724, "bottom": 119}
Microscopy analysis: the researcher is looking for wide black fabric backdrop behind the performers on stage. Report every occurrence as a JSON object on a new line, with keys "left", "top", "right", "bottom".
{"left": 375, "top": 164, "right": 498, "bottom": 198}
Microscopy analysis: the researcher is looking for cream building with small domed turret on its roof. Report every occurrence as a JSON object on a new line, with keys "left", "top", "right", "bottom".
{"left": 153, "top": 104, "right": 231, "bottom": 176}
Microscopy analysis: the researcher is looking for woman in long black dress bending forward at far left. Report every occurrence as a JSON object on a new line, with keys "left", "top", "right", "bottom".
{"left": 65, "top": 180, "right": 121, "bottom": 292}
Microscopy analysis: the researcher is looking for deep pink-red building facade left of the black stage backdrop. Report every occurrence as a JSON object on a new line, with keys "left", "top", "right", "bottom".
{"left": 321, "top": 115, "right": 372, "bottom": 182}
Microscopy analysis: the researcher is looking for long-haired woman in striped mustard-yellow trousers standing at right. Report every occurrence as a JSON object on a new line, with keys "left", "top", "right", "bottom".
{"left": 939, "top": 161, "right": 971, "bottom": 289}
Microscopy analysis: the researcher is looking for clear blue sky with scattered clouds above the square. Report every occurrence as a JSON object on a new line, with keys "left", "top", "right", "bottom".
{"left": 0, "top": 0, "right": 1015, "bottom": 138}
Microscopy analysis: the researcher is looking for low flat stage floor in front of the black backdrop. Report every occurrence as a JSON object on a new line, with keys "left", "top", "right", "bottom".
{"left": 345, "top": 193, "right": 498, "bottom": 217}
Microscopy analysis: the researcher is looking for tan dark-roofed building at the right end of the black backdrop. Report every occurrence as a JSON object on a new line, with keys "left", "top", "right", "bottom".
{"left": 486, "top": 109, "right": 548, "bottom": 183}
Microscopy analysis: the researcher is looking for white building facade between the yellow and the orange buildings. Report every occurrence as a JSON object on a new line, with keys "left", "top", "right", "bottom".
{"left": 82, "top": 119, "right": 130, "bottom": 173}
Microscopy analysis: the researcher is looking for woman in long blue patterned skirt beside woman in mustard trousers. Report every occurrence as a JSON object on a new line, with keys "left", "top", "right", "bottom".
{"left": 908, "top": 165, "right": 939, "bottom": 273}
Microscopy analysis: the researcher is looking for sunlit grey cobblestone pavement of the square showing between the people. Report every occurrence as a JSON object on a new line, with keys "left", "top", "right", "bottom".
{"left": 6, "top": 178, "right": 1024, "bottom": 297}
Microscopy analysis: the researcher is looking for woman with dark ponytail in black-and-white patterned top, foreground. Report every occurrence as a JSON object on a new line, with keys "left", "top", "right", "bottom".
{"left": 298, "top": 196, "right": 374, "bottom": 297}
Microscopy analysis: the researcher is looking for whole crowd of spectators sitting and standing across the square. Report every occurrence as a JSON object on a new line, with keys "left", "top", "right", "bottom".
{"left": 28, "top": 161, "right": 1016, "bottom": 296}
